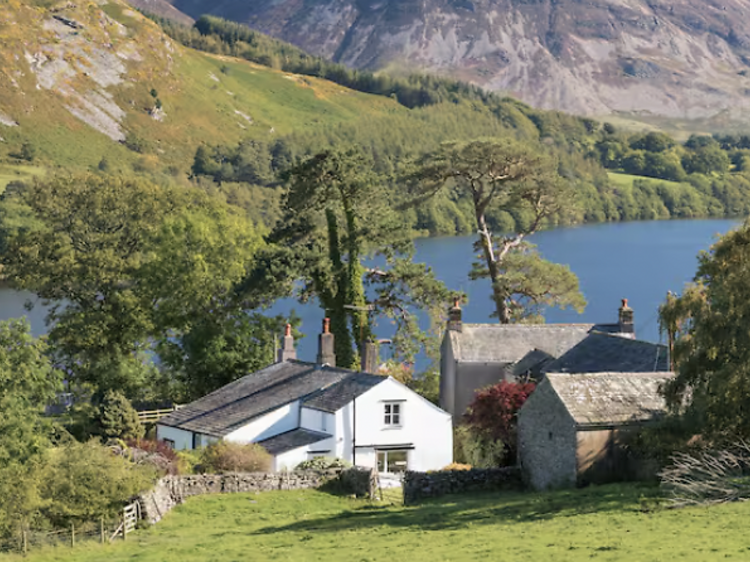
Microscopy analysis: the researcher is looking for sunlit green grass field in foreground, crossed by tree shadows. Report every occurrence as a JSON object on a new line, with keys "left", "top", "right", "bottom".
{"left": 8, "top": 486, "right": 750, "bottom": 562}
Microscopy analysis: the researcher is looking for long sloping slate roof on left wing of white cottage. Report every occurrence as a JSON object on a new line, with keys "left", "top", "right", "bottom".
{"left": 159, "top": 361, "right": 385, "bottom": 437}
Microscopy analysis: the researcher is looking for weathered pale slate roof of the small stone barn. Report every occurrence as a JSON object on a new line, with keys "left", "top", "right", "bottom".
{"left": 542, "top": 372, "right": 674, "bottom": 426}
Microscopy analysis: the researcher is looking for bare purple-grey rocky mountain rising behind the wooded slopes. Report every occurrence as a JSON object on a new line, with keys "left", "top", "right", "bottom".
{"left": 163, "top": 0, "right": 750, "bottom": 128}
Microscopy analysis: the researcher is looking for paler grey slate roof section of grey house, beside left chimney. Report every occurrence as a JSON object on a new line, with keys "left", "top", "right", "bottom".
{"left": 448, "top": 324, "right": 596, "bottom": 364}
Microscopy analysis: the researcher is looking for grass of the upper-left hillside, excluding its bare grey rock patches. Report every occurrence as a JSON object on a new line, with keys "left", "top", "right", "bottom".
{"left": 0, "top": 0, "right": 406, "bottom": 171}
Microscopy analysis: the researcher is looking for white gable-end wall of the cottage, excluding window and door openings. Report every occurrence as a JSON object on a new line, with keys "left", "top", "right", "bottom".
{"left": 335, "top": 378, "right": 453, "bottom": 471}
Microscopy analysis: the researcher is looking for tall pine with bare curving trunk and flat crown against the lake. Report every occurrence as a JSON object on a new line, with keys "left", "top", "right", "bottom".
{"left": 410, "top": 139, "right": 585, "bottom": 323}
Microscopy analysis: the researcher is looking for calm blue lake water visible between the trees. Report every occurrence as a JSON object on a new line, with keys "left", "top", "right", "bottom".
{"left": 0, "top": 220, "right": 740, "bottom": 360}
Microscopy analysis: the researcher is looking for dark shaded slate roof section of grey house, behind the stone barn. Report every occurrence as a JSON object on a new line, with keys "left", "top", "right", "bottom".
{"left": 542, "top": 333, "right": 669, "bottom": 373}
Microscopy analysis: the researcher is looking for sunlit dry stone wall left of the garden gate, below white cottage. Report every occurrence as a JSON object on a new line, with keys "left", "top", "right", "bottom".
{"left": 138, "top": 467, "right": 378, "bottom": 523}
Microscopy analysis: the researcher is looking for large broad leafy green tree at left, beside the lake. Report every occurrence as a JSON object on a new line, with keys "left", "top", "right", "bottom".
{"left": 0, "top": 175, "right": 260, "bottom": 398}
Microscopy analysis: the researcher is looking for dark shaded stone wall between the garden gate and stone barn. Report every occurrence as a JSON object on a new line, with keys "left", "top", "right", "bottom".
{"left": 403, "top": 466, "right": 523, "bottom": 505}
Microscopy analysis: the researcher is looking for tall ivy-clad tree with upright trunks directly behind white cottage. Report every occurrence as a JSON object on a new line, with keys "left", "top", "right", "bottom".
{"left": 269, "top": 149, "right": 449, "bottom": 368}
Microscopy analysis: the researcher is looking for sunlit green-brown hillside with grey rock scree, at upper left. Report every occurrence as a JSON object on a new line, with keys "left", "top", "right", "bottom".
{"left": 0, "top": 0, "right": 406, "bottom": 177}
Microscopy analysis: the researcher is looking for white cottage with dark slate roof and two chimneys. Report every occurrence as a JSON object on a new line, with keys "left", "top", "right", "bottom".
{"left": 157, "top": 320, "right": 453, "bottom": 472}
